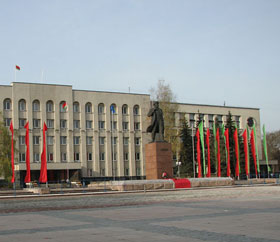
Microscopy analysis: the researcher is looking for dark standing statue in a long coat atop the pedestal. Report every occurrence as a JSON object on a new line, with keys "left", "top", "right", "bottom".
{"left": 147, "top": 102, "right": 164, "bottom": 142}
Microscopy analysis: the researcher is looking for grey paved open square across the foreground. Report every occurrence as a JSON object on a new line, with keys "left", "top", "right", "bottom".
{"left": 0, "top": 186, "right": 280, "bottom": 242}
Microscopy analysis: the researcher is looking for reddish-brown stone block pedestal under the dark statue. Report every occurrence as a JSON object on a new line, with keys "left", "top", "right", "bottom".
{"left": 145, "top": 142, "right": 173, "bottom": 180}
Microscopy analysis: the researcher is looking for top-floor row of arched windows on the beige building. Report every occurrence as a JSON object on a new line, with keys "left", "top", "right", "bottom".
{"left": 4, "top": 98, "right": 140, "bottom": 115}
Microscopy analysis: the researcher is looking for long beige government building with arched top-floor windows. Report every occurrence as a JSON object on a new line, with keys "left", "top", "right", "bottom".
{"left": 0, "top": 82, "right": 261, "bottom": 181}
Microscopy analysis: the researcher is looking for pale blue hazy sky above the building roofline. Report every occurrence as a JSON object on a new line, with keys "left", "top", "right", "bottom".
{"left": 0, "top": 0, "right": 280, "bottom": 132}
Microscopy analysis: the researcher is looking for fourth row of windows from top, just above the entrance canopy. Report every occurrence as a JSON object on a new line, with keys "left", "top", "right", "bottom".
{"left": 19, "top": 152, "right": 140, "bottom": 163}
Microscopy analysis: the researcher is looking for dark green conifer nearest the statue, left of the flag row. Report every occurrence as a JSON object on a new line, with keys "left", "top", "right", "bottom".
{"left": 179, "top": 118, "right": 193, "bottom": 176}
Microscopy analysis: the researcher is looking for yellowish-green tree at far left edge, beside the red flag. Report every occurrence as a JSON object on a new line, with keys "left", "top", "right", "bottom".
{"left": 0, "top": 114, "right": 12, "bottom": 182}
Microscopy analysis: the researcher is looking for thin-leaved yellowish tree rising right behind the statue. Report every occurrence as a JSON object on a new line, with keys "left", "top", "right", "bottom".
{"left": 150, "top": 80, "right": 179, "bottom": 154}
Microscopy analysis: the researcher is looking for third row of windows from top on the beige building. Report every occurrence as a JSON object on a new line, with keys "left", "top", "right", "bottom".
{"left": 19, "top": 135, "right": 141, "bottom": 145}
